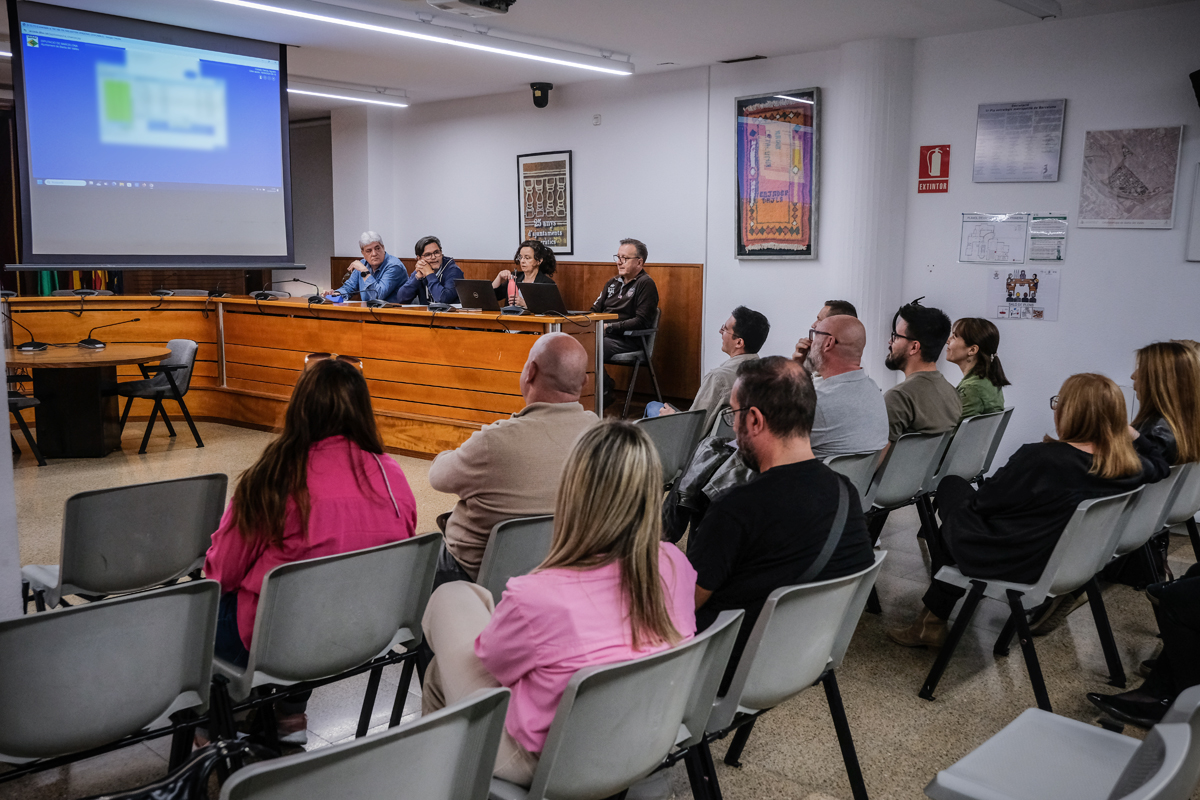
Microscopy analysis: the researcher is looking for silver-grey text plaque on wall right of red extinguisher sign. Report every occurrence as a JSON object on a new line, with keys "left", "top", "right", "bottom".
{"left": 972, "top": 100, "right": 1067, "bottom": 184}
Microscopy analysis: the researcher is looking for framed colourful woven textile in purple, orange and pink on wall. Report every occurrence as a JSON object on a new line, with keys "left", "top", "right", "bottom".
{"left": 734, "top": 89, "right": 821, "bottom": 259}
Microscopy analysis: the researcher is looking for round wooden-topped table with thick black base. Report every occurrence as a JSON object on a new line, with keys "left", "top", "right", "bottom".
{"left": 5, "top": 344, "right": 170, "bottom": 458}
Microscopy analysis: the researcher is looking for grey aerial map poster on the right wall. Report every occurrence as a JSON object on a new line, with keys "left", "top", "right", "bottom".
{"left": 1079, "top": 126, "right": 1183, "bottom": 228}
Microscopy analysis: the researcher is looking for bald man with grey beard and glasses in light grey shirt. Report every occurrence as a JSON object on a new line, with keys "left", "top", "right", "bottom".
{"left": 803, "top": 315, "right": 888, "bottom": 458}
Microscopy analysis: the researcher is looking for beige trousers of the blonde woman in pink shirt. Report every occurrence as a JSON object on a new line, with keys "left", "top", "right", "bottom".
{"left": 421, "top": 581, "right": 538, "bottom": 787}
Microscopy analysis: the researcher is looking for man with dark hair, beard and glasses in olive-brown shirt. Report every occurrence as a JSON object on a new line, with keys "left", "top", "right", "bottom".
{"left": 883, "top": 297, "right": 962, "bottom": 443}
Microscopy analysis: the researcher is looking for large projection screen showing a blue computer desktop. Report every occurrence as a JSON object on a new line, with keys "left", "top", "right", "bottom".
{"left": 14, "top": 4, "right": 292, "bottom": 263}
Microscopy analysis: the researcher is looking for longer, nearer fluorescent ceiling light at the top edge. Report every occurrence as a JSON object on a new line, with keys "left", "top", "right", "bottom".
{"left": 214, "top": 0, "right": 634, "bottom": 76}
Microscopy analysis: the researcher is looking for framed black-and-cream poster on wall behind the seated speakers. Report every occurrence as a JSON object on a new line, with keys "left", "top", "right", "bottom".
{"left": 517, "top": 150, "right": 575, "bottom": 255}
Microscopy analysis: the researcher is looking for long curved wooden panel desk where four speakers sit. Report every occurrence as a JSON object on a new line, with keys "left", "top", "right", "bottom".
{"left": 7, "top": 296, "right": 614, "bottom": 457}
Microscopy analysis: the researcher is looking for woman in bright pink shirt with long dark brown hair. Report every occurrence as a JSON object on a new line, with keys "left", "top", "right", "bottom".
{"left": 211, "top": 359, "right": 416, "bottom": 744}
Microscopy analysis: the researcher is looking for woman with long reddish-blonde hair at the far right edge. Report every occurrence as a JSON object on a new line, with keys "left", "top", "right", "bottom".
{"left": 1132, "top": 342, "right": 1200, "bottom": 464}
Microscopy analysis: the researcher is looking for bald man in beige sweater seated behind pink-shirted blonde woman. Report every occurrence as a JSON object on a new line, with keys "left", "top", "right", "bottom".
{"left": 430, "top": 333, "right": 599, "bottom": 583}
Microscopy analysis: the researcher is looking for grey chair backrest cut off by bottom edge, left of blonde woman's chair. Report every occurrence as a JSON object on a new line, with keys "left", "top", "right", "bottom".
{"left": 221, "top": 688, "right": 509, "bottom": 800}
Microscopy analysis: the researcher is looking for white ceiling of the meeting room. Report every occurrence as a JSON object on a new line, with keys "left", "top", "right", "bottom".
{"left": 0, "top": 0, "right": 1190, "bottom": 119}
